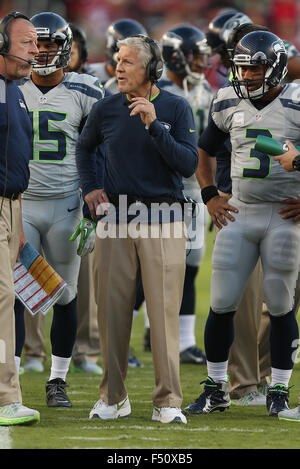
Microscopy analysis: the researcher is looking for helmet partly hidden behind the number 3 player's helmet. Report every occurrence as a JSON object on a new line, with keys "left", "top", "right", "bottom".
{"left": 206, "top": 10, "right": 253, "bottom": 58}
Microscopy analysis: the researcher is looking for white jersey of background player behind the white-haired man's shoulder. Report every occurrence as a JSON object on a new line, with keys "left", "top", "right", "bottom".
{"left": 158, "top": 78, "right": 213, "bottom": 192}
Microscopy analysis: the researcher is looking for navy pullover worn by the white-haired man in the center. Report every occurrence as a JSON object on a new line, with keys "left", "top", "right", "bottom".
{"left": 76, "top": 90, "right": 198, "bottom": 200}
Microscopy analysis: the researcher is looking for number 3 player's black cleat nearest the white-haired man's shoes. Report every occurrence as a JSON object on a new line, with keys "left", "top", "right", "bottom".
{"left": 183, "top": 376, "right": 230, "bottom": 415}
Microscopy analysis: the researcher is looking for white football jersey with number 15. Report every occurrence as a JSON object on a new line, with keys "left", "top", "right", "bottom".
{"left": 19, "top": 72, "right": 104, "bottom": 199}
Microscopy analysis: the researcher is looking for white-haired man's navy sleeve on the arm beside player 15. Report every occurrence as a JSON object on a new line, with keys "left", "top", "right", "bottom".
{"left": 76, "top": 101, "right": 103, "bottom": 195}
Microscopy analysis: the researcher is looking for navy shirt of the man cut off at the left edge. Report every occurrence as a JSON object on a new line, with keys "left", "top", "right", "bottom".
{"left": 0, "top": 75, "right": 33, "bottom": 196}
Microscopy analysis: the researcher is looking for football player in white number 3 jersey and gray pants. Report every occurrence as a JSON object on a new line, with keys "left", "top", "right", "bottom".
{"left": 185, "top": 31, "right": 300, "bottom": 416}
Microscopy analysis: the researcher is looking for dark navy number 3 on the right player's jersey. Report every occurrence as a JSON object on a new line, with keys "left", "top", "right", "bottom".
{"left": 243, "top": 129, "right": 272, "bottom": 179}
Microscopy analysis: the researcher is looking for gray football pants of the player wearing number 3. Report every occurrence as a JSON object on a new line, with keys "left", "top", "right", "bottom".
{"left": 211, "top": 197, "right": 300, "bottom": 316}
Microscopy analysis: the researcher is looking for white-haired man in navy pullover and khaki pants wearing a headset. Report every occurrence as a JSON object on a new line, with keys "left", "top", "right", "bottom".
{"left": 76, "top": 36, "right": 198, "bottom": 423}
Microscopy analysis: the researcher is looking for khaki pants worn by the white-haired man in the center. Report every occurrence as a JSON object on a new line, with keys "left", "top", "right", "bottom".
{"left": 93, "top": 222, "right": 186, "bottom": 407}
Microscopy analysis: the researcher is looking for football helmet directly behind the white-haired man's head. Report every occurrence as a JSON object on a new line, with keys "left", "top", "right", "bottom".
{"left": 105, "top": 18, "right": 148, "bottom": 68}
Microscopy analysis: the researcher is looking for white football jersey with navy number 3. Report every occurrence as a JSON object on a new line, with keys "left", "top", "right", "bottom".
{"left": 212, "top": 83, "right": 300, "bottom": 203}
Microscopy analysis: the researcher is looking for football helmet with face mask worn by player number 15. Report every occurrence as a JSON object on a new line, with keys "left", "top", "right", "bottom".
{"left": 30, "top": 12, "right": 72, "bottom": 75}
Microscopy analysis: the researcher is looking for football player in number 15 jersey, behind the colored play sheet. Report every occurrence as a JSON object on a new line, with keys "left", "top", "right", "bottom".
{"left": 15, "top": 12, "right": 104, "bottom": 407}
